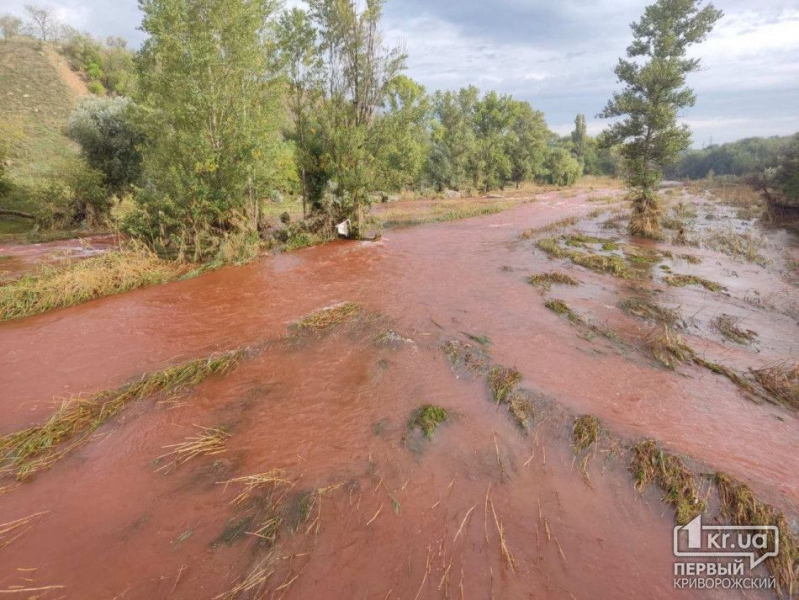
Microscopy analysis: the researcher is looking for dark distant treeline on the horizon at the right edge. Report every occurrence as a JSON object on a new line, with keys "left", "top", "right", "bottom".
{"left": 665, "top": 136, "right": 793, "bottom": 179}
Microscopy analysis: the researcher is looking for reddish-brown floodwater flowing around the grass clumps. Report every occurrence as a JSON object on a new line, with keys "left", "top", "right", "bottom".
{"left": 0, "top": 189, "right": 799, "bottom": 599}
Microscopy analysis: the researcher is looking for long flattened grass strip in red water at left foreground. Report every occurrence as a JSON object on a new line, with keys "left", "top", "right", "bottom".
{"left": 0, "top": 350, "right": 244, "bottom": 479}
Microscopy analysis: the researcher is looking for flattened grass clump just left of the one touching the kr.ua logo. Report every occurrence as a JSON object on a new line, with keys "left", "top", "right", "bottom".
{"left": 630, "top": 440, "right": 707, "bottom": 525}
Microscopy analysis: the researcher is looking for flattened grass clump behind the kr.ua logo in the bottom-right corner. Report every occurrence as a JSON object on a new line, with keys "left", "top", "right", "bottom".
{"left": 714, "top": 473, "right": 799, "bottom": 598}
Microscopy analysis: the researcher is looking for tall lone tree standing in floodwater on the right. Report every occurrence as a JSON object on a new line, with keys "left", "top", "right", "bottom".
{"left": 599, "top": 0, "right": 723, "bottom": 237}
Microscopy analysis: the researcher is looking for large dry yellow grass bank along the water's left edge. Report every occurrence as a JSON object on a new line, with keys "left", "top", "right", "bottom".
{"left": 0, "top": 247, "right": 183, "bottom": 321}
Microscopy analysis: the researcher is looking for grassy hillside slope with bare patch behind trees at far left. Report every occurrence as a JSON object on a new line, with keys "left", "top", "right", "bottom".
{"left": 0, "top": 39, "right": 87, "bottom": 233}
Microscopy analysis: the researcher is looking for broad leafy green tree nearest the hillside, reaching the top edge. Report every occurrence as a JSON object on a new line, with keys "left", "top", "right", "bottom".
{"left": 130, "top": 0, "right": 283, "bottom": 260}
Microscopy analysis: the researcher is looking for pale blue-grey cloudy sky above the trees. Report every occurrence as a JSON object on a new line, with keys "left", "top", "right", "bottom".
{"left": 6, "top": 0, "right": 799, "bottom": 147}
